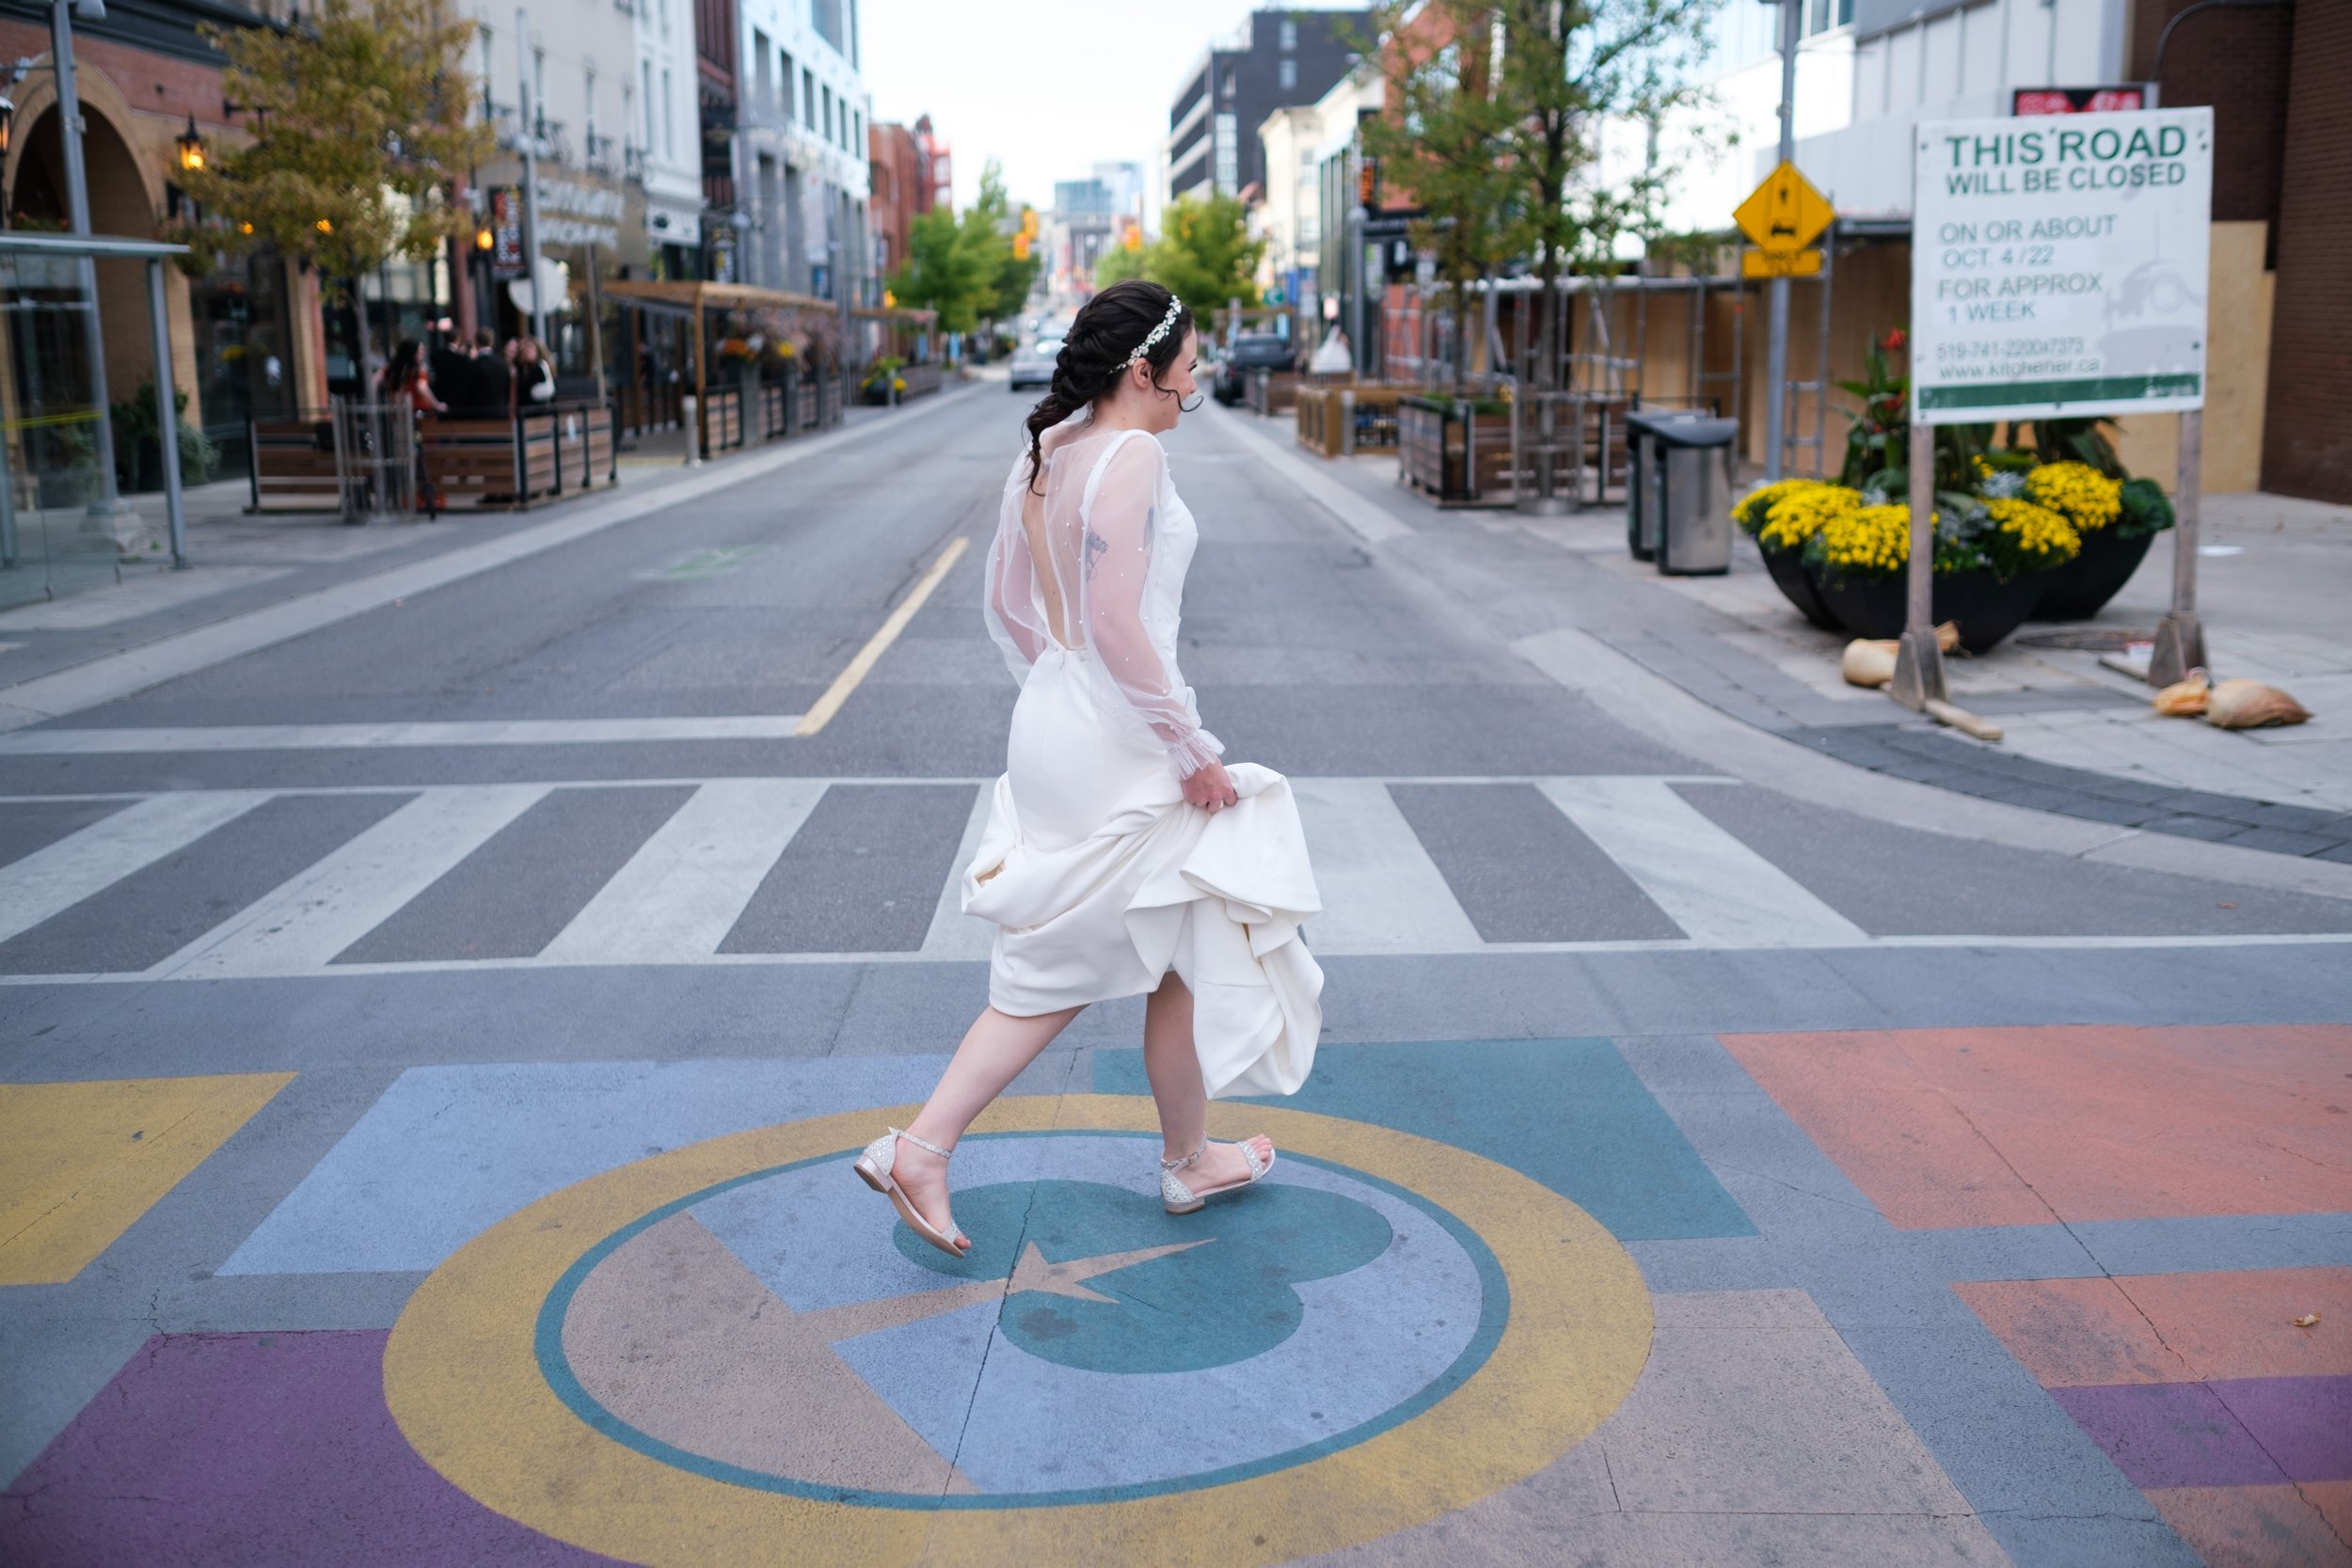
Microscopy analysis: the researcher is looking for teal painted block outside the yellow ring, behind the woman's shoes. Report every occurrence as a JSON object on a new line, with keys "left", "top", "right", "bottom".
{"left": 1094, "top": 1039, "right": 1757, "bottom": 1242}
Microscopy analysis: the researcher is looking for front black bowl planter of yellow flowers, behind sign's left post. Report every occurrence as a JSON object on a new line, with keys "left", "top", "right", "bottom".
{"left": 1806, "top": 491, "right": 2082, "bottom": 654}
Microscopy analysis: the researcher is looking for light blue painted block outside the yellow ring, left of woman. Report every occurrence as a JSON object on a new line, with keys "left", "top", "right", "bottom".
{"left": 221, "top": 1055, "right": 946, "bottom": 1275}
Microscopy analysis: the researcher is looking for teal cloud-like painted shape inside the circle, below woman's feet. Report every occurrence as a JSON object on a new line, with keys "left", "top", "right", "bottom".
{"left": 892, "top": 1180, "right": 1392, "bottom": 1373}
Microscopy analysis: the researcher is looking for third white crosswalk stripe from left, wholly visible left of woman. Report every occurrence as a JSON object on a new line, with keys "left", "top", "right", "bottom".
{"left": 539, "top": 778, "right": 828, "bottom": 964}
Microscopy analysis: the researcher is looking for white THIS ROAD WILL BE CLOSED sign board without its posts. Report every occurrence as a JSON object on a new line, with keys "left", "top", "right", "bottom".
{"left": 1913, "top": 108, "right": 2214, "bottom": 425}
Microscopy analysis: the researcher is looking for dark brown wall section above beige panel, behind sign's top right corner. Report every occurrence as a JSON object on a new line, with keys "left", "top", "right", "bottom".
{"left": 2131, "top": 0, "right": 2286, "bottom": 232}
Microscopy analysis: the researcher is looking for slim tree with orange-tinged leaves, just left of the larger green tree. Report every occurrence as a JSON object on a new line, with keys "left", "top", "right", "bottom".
{"left": 1364, "top": 0, "right": 1518, "bottom": 395}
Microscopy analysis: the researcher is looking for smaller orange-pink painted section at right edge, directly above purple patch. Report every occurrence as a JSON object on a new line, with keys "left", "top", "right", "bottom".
{"left": 1952, "top": 1270, "right": 2352, "bottom": 1389}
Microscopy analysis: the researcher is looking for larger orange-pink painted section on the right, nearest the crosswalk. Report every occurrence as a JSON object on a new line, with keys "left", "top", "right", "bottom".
{"left": 1722, "top": 1025, "right": 2352, "bottom": 1229}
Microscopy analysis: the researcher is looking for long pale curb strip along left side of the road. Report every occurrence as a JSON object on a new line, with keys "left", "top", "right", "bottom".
{"left": 0, "top": 386, "right": 977, "bottom": 731}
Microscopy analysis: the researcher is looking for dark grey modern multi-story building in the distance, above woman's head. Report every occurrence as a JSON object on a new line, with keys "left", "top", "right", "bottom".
{"left": 1162, "top": 9, "right": 1372, "bottom": 199}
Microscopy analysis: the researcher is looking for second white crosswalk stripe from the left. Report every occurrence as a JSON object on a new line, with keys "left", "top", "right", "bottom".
{"left": 155, "top": 785, "right": 548, "bottom": 980}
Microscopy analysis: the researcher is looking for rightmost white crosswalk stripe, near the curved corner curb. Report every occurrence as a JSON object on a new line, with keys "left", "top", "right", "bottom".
{"left": 1536, "top": 776, "right": 1870, "bottom": 947}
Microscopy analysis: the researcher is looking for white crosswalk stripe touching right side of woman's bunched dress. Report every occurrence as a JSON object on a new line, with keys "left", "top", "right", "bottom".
{"left": 1292, "top": 778, "right": 1485, "bottom": 955}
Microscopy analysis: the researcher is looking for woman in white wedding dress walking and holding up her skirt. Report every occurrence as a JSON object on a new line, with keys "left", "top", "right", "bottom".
{"left": 856, "top": 279, "right": 1322, "bottom": 1256}
